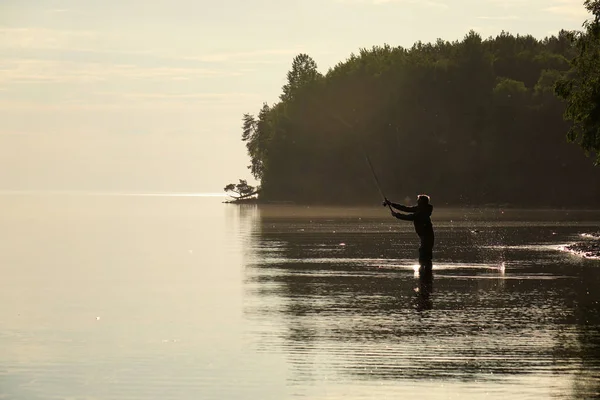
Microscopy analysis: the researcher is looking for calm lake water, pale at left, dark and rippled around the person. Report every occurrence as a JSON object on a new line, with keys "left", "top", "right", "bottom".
{"left": 0, "top": 193, "right": 600, "bottom": 400}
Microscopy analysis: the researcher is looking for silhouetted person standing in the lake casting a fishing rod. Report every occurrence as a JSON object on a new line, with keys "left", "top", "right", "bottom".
{"left": 383, "top": 194, "right": 435, "bottom": 273}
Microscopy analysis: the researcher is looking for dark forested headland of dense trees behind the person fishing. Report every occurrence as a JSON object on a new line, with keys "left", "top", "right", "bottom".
{"left": 237, "top": 27, "right": 600, "bottom": 206}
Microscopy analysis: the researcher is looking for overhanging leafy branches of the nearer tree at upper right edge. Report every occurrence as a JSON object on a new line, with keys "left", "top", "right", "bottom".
{"left": 556, "top": 0, "right": 600, "bottom": 165}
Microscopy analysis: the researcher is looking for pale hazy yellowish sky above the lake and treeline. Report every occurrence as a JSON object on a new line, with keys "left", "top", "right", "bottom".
{"left": 0, "top": 0, "right": 587, "bottom": 192}
